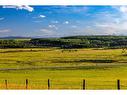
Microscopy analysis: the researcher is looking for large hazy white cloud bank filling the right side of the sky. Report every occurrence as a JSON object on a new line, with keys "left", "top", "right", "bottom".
{"left": 80, "top": 6, "right": 127, "bottom": 35}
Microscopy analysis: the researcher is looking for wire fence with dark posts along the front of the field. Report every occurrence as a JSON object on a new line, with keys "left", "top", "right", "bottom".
{"left": 0, "top": 79, "right": 127, "bottom": 90}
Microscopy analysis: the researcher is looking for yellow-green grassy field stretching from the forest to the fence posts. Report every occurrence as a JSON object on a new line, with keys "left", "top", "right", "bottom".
{"left": 0, "top": 48, "right": 127, "bottom": 89}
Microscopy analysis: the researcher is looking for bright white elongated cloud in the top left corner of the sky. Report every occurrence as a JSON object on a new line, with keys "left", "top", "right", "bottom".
{"left": 3, "top": 5, "right": 34, "bottom": 12}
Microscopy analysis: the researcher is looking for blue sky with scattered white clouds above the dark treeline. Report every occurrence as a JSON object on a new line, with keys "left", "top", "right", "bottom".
{"left": 0, "top": 5, "right": 127, "bottom": 37}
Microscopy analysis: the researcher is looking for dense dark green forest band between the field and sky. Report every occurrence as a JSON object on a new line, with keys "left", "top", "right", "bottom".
{"left": 0, "top": 36, "right": 127, "bottom": 48}
